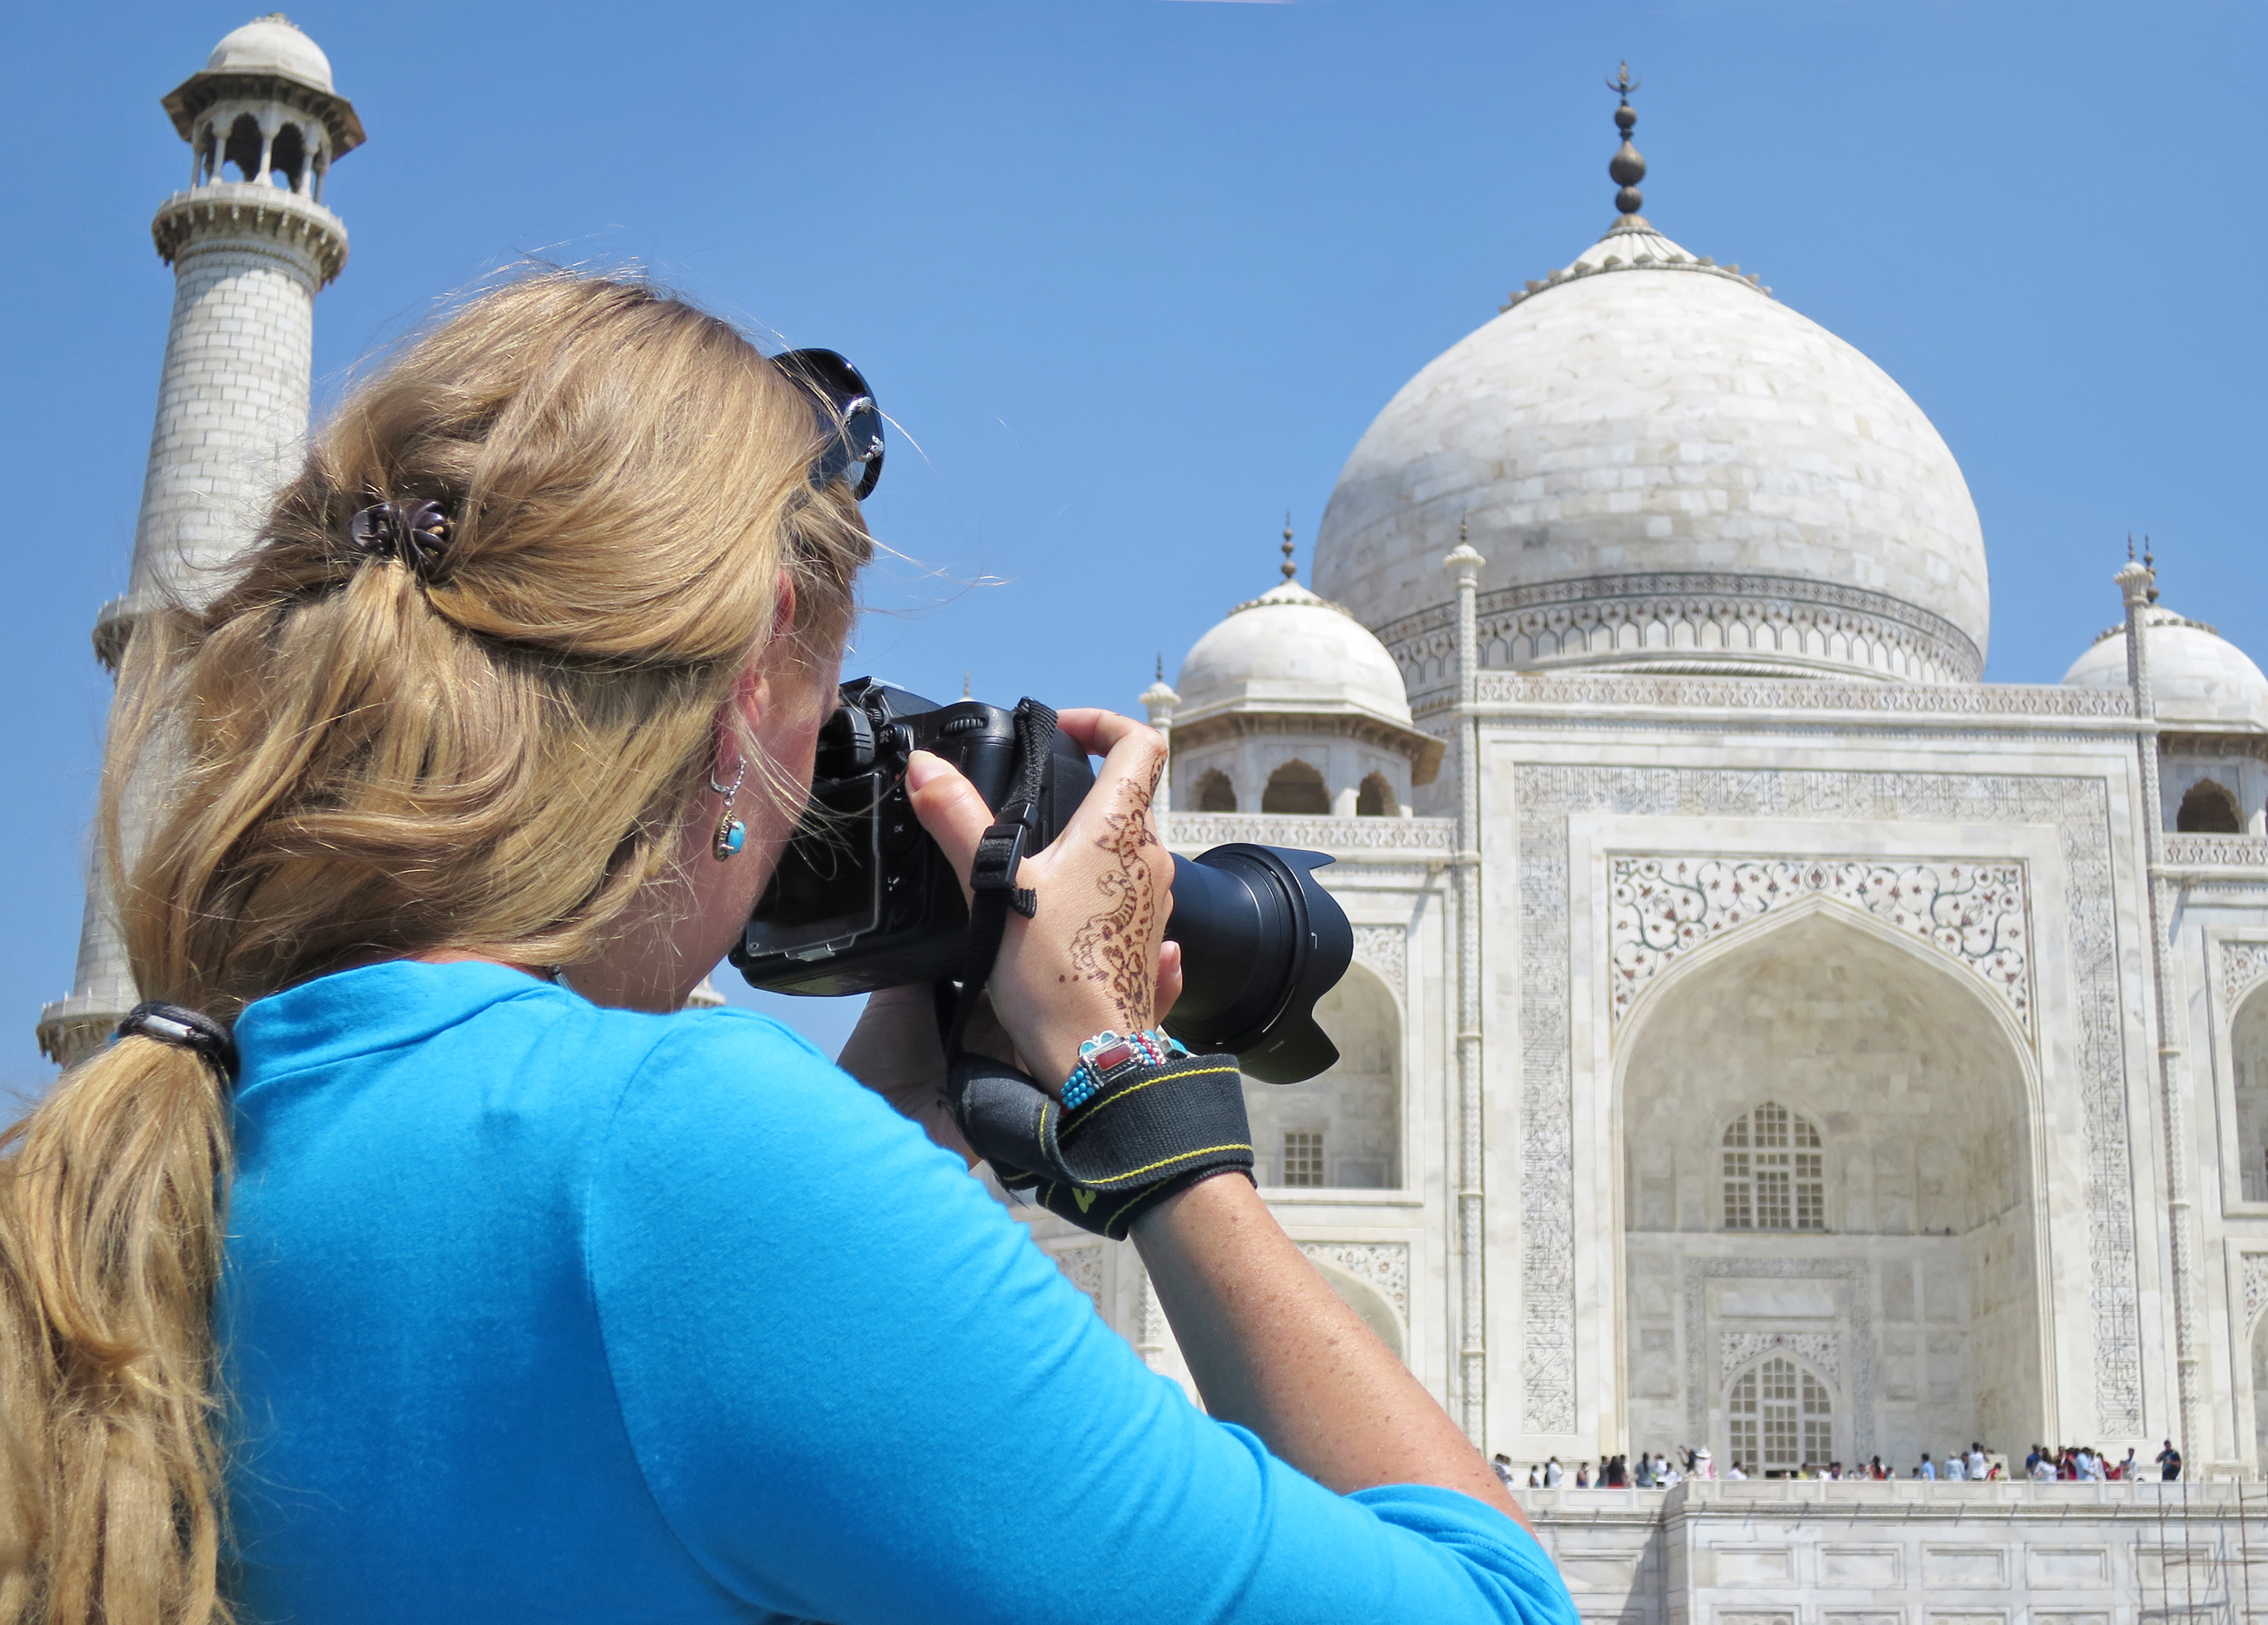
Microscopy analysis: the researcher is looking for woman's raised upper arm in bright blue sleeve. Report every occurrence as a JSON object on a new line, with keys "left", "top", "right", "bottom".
{"left": 583, "top": 1010, "right": 1577, "bottom": 1625}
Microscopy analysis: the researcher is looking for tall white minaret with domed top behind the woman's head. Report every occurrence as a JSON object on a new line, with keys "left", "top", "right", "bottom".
{"left": 39, "top": 22, "right": 363, "bottom": 1067}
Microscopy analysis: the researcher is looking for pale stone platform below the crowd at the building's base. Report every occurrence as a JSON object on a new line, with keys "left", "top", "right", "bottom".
{"left": 1515, "top": 1480, "right": 2268, "bottom": 1625}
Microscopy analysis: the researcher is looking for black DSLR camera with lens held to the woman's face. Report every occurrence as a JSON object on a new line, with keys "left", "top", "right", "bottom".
{"left": 733, "top": 676, "right": 1354, "bottom": 1082}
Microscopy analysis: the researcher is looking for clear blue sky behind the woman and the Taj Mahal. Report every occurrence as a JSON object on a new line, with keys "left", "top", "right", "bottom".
{"left": 0, "top": 0, "right": 2268, "bottom": 1087}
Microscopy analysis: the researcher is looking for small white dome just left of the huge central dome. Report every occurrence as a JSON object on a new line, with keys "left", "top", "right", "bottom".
{"left": 1175, "top": 581, "right": 1411, "bottom": 729}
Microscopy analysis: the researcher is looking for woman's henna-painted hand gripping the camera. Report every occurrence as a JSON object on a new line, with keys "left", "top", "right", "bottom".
{"left": 905, "top": 710, "right": 1182, "bottom": 1090}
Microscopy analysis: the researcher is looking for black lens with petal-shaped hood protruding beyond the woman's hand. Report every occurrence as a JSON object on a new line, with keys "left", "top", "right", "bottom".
{"left": 1166, "top": 842, "right": 1354, "bottom": 1082}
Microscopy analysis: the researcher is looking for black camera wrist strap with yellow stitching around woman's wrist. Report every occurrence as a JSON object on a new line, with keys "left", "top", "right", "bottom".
{"left": 937, "top": 699, "right": 1252, "bottom": 1239}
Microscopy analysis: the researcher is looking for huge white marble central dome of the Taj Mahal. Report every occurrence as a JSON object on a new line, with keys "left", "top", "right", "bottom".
{"left": 1315, "top": 218, "right": 1989, "bottom": 688}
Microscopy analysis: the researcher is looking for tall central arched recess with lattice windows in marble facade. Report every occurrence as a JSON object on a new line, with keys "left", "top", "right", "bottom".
{"left": 1618, "top": 901, "right": 2044, "bottom": 1471}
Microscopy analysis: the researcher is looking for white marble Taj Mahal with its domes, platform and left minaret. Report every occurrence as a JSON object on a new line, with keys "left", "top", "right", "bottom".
{"left": 41, "top": 18, "right": 2268, "bottom": 1625}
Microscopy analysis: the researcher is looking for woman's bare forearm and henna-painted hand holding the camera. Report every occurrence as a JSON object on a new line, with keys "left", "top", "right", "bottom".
{"left": 912, "top": 710, "right": 1527, "bottom": 1522}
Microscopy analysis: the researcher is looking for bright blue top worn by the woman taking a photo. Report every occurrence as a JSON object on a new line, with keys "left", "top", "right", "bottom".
{"left": 220, "top": 963, "right": 1574, "bottom": 1625}
